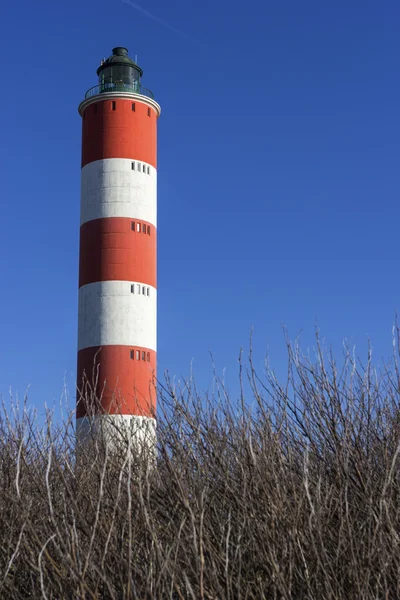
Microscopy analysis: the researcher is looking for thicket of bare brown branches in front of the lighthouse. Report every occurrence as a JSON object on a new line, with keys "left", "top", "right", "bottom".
{"left": 0, "top": 338, "right": 400, "bottom": 600}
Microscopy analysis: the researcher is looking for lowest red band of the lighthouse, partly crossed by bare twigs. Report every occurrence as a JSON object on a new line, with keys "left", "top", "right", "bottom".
{"left": 76, "top": 346, "right": 156, "bottom": 419}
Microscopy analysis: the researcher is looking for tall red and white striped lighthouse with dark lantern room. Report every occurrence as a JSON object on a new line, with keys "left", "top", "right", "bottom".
{"left": 76, "top": 47, "right": 160, "bottom": 437}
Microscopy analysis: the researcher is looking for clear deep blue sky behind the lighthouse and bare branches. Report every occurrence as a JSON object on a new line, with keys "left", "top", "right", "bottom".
{"left": 0, "top": 0, "right": 400, "bottom": 409}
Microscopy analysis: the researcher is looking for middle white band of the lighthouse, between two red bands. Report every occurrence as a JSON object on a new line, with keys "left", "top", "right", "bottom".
{"left": 78, "top": 281, "right": 157, "bottom": 352}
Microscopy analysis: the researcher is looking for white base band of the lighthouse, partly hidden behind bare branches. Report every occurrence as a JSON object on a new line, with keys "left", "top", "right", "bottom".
{"left": 76, "top": 415, "right": 157, "bottom": 453}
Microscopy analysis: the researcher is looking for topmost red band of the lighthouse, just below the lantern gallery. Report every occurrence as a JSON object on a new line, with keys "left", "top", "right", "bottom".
{"left": 82, "top": 98, "right": 157, "bottom": 167}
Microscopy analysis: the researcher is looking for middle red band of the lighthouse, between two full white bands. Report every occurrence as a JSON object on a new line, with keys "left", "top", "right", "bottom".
{"left": 79, "top": 218, "right": 157, "bottom": 287}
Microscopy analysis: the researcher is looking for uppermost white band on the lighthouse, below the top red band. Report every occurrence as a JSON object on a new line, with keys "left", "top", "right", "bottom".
{"left": 81, "top": 158, "right": 157, "bottom": 226}
